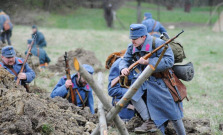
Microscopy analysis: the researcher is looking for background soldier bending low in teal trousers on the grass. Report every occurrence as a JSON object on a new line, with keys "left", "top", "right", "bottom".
{"left": 27, "top": 39, "right": 50, "bottom": 68}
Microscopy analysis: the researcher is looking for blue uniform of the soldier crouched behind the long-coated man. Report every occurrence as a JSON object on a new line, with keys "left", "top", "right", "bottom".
{"left": 108, "top": 58, "right": 135, "bottom": 120}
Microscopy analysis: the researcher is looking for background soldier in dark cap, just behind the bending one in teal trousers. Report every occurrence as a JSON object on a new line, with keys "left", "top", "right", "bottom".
{"left": 32, "top": 25, "right": 47, "bottom": 48}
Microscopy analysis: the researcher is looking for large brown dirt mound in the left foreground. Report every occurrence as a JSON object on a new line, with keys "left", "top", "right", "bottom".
{"left": 0, "top": 68, "right": 98, "bottom": 135}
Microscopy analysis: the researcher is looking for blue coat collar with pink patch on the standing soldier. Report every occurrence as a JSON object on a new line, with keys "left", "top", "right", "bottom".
{"left": 132, "top": 34, "right": 152, "bottom": 54}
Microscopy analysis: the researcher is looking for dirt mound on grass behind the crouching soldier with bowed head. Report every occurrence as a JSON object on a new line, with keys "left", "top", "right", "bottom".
{"left": 48, "top": 48, "right": 103, "bottom": 73}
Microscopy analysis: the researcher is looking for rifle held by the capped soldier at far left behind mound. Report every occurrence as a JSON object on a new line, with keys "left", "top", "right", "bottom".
{"left": 16, "top": 34, "right": 37, "bottom": 92}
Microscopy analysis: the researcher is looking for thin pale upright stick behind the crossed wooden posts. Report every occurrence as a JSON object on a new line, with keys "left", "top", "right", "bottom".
{"left": 98, "top": 72, "right": 108, "bottom": 135}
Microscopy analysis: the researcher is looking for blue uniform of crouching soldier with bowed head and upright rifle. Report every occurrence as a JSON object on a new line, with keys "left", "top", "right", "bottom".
{"left": 50, "top": 64, "right": 94, "bottom": 114}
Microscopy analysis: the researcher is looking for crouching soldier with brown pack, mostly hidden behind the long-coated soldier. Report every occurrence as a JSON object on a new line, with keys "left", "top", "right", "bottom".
{"left": 106, "top": 50, "right": 135, "bottom": 121}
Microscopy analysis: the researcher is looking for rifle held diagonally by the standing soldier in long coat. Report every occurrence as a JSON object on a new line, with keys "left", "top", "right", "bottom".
{"left": 111, "top": 30, "right": 184, "bottom": 87}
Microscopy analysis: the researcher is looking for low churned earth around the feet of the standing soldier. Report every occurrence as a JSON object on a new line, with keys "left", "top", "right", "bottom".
{"left": 126, "top": 117, "right": 212, "bottom": 135}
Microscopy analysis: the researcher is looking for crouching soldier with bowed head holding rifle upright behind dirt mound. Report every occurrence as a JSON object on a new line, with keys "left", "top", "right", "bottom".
{"left": 50, "top": 64, "right": 94, "bottom": 114}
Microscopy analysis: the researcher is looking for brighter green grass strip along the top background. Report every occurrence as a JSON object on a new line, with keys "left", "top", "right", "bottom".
{"left": 41, "top": 2, "right": 222, "bottom": 30}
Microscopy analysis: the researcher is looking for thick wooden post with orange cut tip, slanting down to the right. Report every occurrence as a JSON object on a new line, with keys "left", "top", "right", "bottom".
{"left": 74, "top": 58, "right": 129, "bottom": 135}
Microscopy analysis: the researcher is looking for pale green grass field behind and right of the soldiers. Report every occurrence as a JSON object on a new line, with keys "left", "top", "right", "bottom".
{"left": 12, "top": 26, "right": 223, "bottom": 135}
